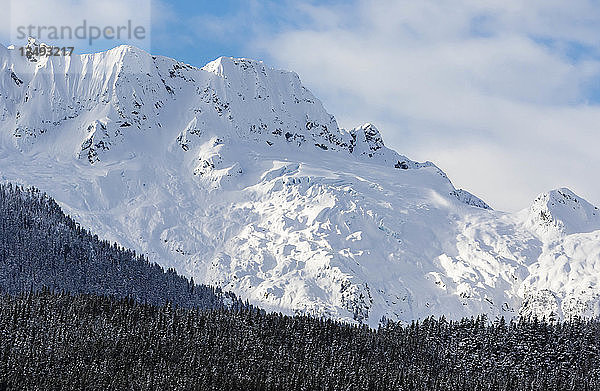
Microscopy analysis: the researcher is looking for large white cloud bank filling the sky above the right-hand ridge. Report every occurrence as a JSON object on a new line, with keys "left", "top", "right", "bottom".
{"left": 255, "top": 0, "right": 600, "bottom": 210}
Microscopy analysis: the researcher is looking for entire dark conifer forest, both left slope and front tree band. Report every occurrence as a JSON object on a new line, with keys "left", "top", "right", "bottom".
{"left": 0, "top": 185, "right": 600, "bottom": 391}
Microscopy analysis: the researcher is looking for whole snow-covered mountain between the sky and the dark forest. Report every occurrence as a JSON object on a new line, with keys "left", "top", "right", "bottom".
{"left": 0, "top": 40, "right": 600, "bottom": 326}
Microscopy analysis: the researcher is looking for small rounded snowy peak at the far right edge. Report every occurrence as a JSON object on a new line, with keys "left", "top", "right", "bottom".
{"left": 528, "top": 187, "right": 600, "bottom": 236}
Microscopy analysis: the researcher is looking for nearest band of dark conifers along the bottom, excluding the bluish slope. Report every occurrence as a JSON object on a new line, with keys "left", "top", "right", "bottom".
{"left": 0, "top": 291, "right": 600, "bottom": 391}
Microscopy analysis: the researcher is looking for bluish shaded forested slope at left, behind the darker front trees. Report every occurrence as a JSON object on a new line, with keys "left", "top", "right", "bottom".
{"left": 0, "top": 185, "right": 242, "bottom": 308}
